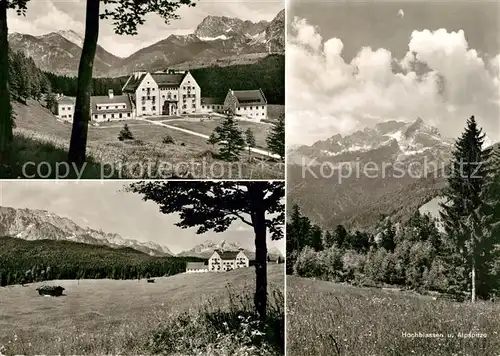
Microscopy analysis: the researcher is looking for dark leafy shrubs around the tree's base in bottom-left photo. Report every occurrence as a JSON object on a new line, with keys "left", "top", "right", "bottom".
{"left": 146, "top": 291, "right": 285, "bottom": 356}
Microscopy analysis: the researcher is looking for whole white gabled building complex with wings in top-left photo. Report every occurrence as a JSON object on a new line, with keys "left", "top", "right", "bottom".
{"left": 53, "top": 70, "right": 267, "bottom": 122}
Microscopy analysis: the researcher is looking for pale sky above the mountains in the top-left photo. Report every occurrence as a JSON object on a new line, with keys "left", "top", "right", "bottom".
{"left": 7, "top": 0, "right": 284, "bottom": 57}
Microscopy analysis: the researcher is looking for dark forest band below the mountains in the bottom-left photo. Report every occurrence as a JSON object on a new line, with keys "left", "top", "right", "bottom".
{"left": 0, "top": 237, "right": 203, "bottom": 286}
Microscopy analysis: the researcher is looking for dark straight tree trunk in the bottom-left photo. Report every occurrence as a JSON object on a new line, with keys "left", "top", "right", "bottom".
{"left": 248, "top": 182, "right": 267, "bottom": 321}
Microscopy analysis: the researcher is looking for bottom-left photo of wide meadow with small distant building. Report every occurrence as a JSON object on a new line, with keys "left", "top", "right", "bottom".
{"left": 0, "top": 180, "right": 285, "bottom": 356}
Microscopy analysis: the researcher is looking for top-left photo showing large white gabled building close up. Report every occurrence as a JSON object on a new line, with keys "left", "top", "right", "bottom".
{"left": 0, "top": 0, "right": 285, "bottom": 180}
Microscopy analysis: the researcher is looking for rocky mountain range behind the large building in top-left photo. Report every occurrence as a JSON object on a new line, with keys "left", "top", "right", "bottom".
{"left": 9, "top": 10, "right": 285, "bottom": 77}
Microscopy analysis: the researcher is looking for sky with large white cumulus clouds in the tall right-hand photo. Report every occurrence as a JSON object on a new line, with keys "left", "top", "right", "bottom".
{"left": 286, "top": 0, "right": 500, "bottom": 146}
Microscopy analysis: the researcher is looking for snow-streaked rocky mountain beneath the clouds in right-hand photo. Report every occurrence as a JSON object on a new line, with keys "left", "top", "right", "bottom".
{"left": 287, "top": 118, "right": 454, "bottom": 229}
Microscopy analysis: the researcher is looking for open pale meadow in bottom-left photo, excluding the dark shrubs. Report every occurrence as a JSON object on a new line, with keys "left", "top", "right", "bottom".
{"left": 0, "top": 265, "right": 284, "bottom": 355}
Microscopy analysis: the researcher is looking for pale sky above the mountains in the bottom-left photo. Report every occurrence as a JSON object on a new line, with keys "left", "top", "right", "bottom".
{"left": 0, "top": 180, "right": 285, "bottom": 253}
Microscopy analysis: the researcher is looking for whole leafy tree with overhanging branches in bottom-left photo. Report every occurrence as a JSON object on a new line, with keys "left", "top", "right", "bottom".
{"left": 129, "top": 181, "right": 285, "bottom": 320}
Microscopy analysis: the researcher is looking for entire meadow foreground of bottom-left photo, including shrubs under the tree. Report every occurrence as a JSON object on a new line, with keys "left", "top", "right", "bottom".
{"left": 0, "top": 265, "right": 284, "bottom": 356}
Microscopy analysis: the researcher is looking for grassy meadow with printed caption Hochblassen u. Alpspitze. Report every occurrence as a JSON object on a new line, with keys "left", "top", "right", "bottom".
{"left": 287, "top": 276, "right": 500, "bottom": 356}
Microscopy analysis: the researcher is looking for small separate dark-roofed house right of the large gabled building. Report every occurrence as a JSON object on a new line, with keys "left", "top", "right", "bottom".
{"left": 224, "top": 89, "right": 267, "bottom": 121}
